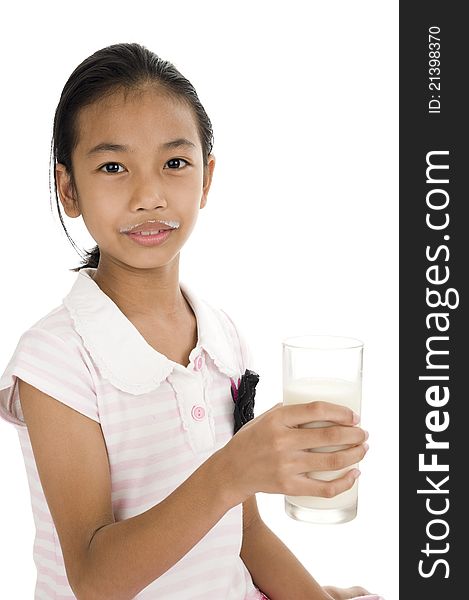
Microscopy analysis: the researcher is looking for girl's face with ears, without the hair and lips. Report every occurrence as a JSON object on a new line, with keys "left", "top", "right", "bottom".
{"left": 56, "top": 88, "right": 215, "bottom": 269}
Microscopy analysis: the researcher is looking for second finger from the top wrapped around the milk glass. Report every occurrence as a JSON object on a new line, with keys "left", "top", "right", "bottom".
{"left": 288, "top": 425, "right": 368, "bottom": 450}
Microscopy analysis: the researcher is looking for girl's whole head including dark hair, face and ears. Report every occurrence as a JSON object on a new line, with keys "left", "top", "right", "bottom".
{"left": 52, "top": 43, "right": 215, "bottom": 271}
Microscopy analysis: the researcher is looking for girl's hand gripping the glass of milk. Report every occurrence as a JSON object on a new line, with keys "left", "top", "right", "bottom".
{"left": 220, "top": 402, "right": 367, "bottom": 504}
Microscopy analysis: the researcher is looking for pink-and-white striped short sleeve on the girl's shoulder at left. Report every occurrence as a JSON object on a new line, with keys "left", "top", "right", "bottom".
{"left": 0, "top": 328, "right": 100, "bottom": 427}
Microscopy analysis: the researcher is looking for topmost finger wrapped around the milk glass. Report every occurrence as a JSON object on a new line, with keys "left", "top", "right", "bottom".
{"left": 279, "top": 401, "right": 360, "bottom": 427}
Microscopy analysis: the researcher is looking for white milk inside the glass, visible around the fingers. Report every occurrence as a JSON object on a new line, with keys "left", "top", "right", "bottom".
{"left": 283, "top": 377, "right": 361, "bottom": 509}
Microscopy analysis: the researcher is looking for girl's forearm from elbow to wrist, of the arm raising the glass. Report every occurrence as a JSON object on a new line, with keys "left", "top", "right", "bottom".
{"left": 79, "top": 453, "right": 231, "bottom": 600}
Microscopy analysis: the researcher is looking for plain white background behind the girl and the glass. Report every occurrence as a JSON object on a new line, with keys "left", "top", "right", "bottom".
{"left": 0, "top": 0, "right": 398, "bottom": 600}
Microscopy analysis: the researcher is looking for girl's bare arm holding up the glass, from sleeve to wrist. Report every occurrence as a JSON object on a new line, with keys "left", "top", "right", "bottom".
{"left": 19, "top": 379, "right": 236, "bottom": 600}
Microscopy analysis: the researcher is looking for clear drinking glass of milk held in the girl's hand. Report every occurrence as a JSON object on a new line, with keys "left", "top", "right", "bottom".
{"left": 282, "top": 335, "right": 363, "bottom": 523}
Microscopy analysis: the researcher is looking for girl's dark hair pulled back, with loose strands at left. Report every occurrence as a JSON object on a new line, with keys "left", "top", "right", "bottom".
{"left": 49, "top": 43, "right": 213, "bottom": 271}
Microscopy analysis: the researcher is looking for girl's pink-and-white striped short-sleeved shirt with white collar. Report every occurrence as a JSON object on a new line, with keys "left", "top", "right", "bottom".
{"left": 0, "top": 268, "right": 262, "bottom": 600}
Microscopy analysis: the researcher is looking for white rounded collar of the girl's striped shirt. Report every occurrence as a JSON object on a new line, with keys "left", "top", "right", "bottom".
{"left": 63, "top": 267, "right": 239, "bottom": 394}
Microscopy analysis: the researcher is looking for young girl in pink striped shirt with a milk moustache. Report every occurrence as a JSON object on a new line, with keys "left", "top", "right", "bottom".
{"left": 0, "top": 44, "right": 378, "bottom": 600}
